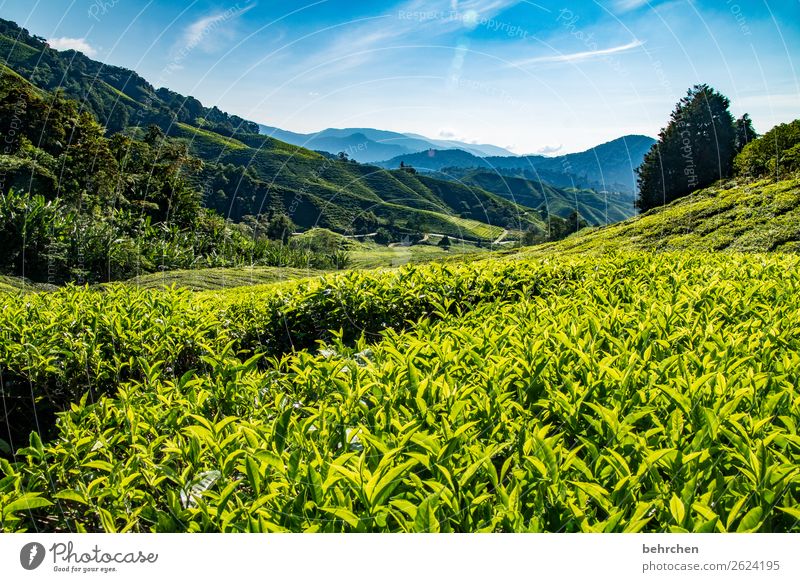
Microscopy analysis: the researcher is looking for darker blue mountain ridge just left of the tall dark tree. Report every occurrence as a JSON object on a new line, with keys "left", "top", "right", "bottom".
{"left": 377, "top": 135, "right": 655, "bottom": 193}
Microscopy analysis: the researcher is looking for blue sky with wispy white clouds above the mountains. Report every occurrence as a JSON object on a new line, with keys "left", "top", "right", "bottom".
{"left": 0, "top": 0, "right": 800, "bottom": 153}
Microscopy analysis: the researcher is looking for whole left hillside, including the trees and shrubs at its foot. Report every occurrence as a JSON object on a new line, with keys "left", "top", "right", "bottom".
{"left": 0, "top": 13, "right": 552, "bottom": 283}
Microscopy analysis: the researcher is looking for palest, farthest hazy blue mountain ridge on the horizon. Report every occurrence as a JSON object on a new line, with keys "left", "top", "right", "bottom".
{"left": 259, "top": 125, "right": 513, "bottom": 163}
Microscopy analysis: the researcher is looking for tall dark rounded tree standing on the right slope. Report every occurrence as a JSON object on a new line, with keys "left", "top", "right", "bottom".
{"left": 636, "top": 84, "right": 736, "bottom": 211}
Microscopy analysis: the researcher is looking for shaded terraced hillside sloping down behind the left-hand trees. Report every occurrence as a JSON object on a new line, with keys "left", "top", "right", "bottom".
{"left": 0, "top": 20, "right": 545, "bottom": 241}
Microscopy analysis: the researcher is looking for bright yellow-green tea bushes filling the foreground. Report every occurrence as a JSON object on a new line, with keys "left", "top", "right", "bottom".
{"left": 0, "top": 254, "right": 800, "bottom": 531}
